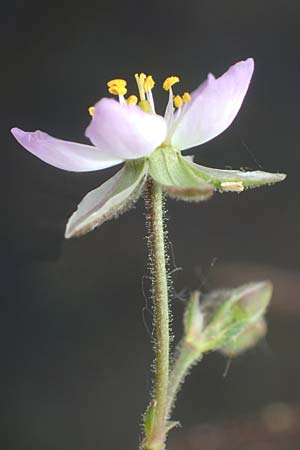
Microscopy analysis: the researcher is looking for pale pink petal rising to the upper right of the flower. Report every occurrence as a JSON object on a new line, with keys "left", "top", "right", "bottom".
{"left": 171, "top": 58, "right": 254, "bottom": 150}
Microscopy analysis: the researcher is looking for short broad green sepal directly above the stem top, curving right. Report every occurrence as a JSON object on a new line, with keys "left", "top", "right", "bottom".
{"left": 149, "top": 146, "right": 214, "bottom": 201}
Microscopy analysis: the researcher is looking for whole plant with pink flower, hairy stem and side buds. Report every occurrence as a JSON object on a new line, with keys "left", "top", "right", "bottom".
{"left": 12, "top": 59, "right": 285, "bottom": 450}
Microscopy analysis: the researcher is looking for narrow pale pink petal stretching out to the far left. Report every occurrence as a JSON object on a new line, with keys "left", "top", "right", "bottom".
{"left": 11, "top": 128, "right": 122, "bottom": 172}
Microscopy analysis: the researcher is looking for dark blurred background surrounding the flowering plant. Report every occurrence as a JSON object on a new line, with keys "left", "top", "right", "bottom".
{"left": 0, "top": 0, "right": 300, "bottom": 450}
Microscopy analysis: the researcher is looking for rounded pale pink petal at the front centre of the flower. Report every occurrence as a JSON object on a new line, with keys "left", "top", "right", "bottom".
{"left": 85, "top": 98, "right": 167, "bottom": 159}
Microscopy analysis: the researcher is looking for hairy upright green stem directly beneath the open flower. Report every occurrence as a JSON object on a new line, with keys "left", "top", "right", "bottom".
{"left": 144, "top": 178, "right": 170, "bottom": 450}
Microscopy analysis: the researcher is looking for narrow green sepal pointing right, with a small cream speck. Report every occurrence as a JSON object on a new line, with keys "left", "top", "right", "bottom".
{"left": 186, "top": 160, "right": 286, "bottom": 192}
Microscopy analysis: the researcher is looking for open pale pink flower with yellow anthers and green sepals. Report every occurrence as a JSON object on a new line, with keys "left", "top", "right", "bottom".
{"left": 12, "top": 58, "right": 285, "bottom": 238}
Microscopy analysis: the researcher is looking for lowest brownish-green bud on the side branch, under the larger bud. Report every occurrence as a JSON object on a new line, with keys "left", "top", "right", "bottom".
{"left": 220, "top": 319, "right": 267, "bottom": 358}
